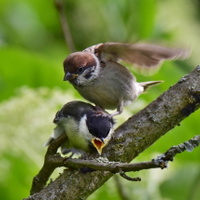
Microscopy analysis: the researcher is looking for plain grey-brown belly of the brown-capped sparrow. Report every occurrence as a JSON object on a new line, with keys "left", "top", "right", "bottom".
{"left": 75, "top": 63, "right": 136, "bottom": 109}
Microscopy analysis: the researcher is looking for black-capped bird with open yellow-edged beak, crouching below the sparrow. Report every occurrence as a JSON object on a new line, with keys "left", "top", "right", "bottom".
{"left": 44, "top": 100, "right": 114, "bottom": 155}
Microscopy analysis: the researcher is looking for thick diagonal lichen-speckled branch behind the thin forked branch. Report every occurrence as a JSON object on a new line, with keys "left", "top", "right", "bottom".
{"left": 24, "top": 66, "right": 200, "bottom": 200}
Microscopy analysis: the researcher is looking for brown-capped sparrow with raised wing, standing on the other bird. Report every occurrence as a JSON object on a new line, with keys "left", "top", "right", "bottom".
{"left": 63, "top": 42, "right": 189, "bottom": 116}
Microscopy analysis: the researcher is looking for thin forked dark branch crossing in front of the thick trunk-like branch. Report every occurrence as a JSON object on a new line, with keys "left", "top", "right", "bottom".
{"left": 31, "top": 135, "right": 200, "bottom": 194}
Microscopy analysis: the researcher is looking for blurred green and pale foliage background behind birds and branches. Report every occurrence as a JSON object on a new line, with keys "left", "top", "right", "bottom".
{"left": 0, "top": 0, "right": 200, "bottom": 200}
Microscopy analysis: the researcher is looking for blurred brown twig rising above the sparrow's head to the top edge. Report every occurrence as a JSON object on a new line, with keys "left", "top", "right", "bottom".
{"left": 55, "top": 0, "right": 75, "bottom": 52}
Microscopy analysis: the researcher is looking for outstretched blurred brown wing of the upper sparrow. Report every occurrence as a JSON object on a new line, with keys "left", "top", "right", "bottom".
{"left": 86, "top": 42, "right": 189, "bottom": 74}
